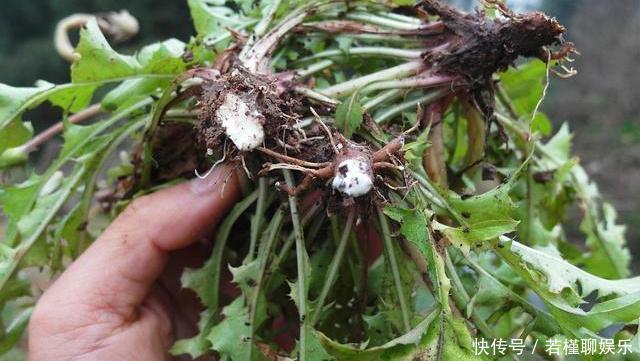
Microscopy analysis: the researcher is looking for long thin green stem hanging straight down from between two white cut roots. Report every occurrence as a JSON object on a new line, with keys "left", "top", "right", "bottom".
{"left": 282, "top": 170, "right": 308, "bottom": 361}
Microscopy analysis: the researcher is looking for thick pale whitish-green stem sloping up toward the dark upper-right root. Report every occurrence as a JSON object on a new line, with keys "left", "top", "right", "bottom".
{"left": 321, "top": 60, "right": 426, "bottom": 98}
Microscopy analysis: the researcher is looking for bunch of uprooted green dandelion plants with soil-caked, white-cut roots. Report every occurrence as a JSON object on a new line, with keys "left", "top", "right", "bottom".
{"left": 0, "top": 0, "right": 640, "bottom": 360}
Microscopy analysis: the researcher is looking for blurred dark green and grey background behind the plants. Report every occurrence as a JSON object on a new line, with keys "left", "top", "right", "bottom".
{"left": 0, "top": 0, "right": 640, "bottom": 258}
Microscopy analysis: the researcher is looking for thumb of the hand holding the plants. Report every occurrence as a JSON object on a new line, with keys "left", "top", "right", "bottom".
{"left": 41, "top": 167, "right": 239, "bottom": 319}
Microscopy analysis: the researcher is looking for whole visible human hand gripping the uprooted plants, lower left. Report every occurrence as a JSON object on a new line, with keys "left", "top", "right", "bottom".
{"left": 29, "top": 167, "right": 239, "bottom": 361}
